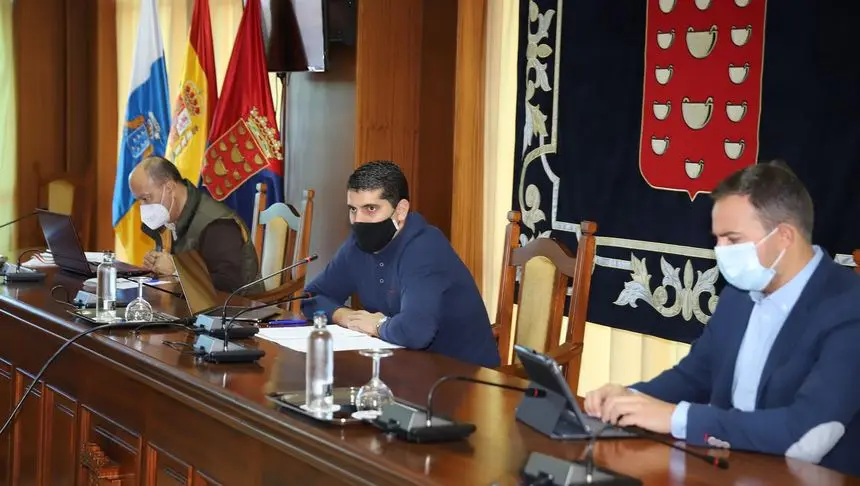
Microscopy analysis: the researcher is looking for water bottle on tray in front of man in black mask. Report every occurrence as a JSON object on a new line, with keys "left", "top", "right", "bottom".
{"left": 305, "top": 311, "right": 334, "bottom": 413}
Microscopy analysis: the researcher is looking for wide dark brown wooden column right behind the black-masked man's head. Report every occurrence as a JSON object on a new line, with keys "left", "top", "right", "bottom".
{"left": 355, "top": 0, "right": 458, "bottom": 236}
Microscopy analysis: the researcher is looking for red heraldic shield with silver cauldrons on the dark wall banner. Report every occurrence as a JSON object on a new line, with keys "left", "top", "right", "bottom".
{"left": 639, "top": 0, "right": 765, "bottom": 200}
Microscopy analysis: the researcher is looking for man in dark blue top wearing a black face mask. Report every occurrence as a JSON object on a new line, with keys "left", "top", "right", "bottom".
{"left": 302, "top": 161, "right": 499, "bottom": 367}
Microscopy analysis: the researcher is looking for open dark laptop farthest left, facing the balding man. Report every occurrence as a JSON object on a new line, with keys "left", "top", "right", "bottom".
{"left": 36, "top": 209, "right": 151, "bottom": 278}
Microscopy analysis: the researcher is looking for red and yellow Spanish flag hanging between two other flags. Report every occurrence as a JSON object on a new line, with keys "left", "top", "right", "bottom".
{"left": 167, "top": 0, "right": 218, "bottom": 183}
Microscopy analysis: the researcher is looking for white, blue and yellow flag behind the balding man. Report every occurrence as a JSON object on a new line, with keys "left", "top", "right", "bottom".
{"left": 113, "top": 0, "right": 170, "bottom": 265}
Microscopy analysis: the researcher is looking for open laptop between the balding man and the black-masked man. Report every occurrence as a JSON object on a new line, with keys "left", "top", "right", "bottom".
{"left": 173, "top": 250, "right": 281, "bottom": 323}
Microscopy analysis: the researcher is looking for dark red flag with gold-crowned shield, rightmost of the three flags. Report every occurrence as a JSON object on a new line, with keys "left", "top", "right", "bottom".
{"left": 200, "top": 0, "right": 284, "bottom": 203}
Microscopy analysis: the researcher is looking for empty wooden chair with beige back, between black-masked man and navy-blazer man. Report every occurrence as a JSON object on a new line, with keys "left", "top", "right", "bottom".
{"left": 494, "top": 211, "right": 597, "bottom": 394}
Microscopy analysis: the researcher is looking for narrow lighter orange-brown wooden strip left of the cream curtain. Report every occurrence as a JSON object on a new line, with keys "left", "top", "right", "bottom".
{"left": 451, "top": 0, "right": 486, "bottom": 282}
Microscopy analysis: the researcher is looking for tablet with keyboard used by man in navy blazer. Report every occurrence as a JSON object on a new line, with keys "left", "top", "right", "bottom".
{"left": 514, "top": 344, "right": 638, "bottom": 440}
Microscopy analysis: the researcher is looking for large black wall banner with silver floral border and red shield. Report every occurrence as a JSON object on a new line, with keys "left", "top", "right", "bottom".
{"left": 513, "top": 0, "right": 860, "bottom": 342}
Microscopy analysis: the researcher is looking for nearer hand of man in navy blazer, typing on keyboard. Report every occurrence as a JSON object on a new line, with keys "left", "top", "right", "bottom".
{"left": 600, "top": 391, "right": 675, "bottom": 434}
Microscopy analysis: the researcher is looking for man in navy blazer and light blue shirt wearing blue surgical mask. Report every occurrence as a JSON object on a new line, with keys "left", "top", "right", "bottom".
{"left": 585, "top": 163, "right": 860, "bottom": 475}
